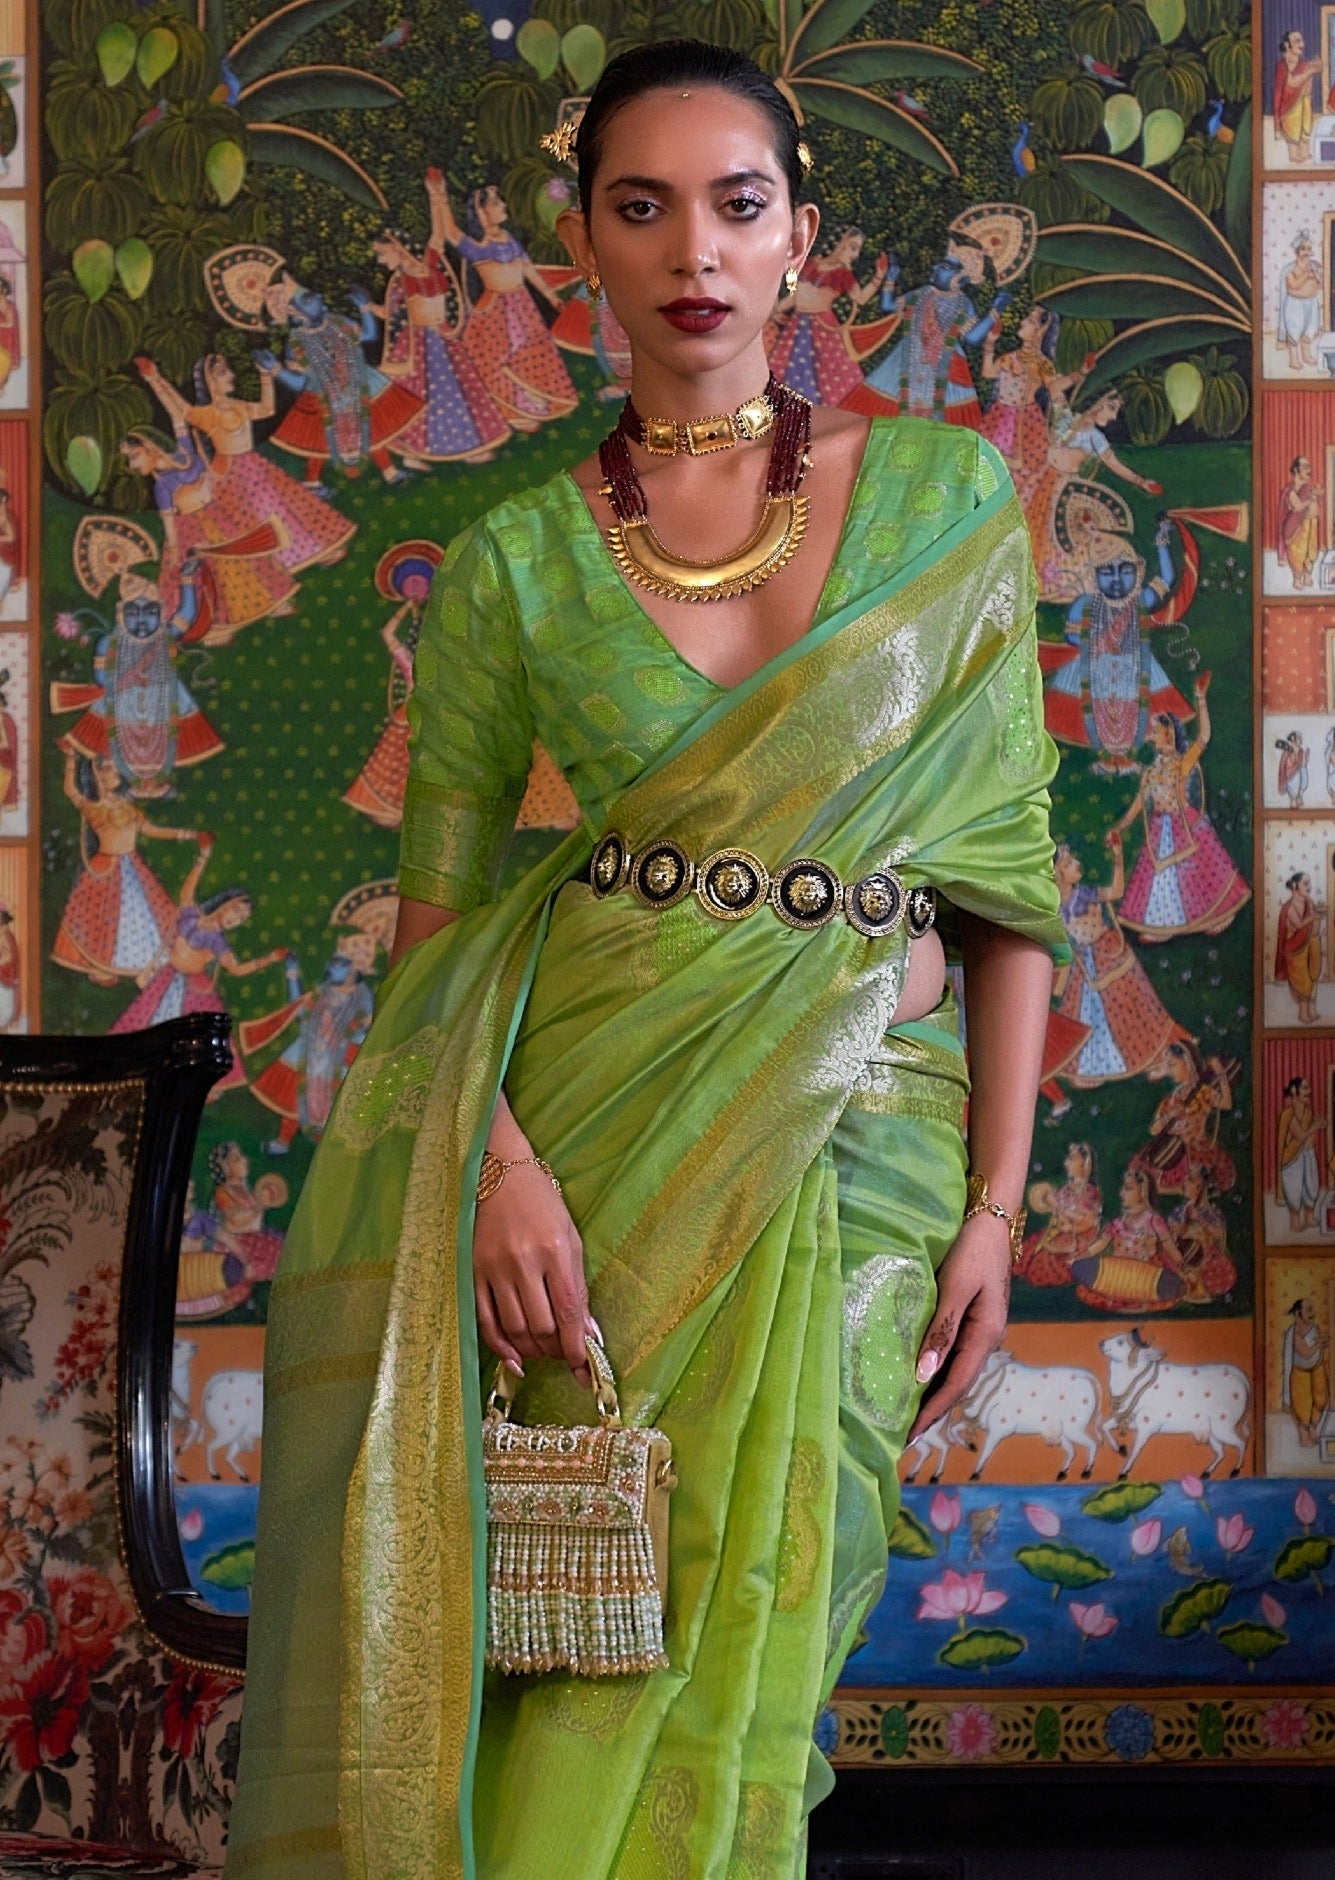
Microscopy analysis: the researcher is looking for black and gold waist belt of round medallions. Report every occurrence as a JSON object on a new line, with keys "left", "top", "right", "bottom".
{"left": 589, "top": 829, "right": 936, "bottom": 940}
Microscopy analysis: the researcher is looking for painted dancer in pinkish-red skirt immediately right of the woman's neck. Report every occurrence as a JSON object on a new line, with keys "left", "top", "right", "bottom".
{"left": 769, "top": 227, "right": 895, "bottom": 414}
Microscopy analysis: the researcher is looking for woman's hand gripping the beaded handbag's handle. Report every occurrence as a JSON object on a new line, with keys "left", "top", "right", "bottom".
{"left": 472, "top": 1162, "right": 602, "bottom": 1389}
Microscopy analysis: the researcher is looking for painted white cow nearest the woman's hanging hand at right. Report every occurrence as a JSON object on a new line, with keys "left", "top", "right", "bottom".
{"left": 908, "top": 1352, "right": 1098, "bottom": 1481}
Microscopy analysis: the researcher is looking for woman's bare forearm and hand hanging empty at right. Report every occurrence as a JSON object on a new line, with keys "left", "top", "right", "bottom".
{"left": 908, "top": 910, "right": 1053, "bottom": 1442}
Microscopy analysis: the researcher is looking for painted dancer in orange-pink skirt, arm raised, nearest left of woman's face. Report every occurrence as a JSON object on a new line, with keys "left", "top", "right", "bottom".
{"left": 439, "top": 177, "right": 579, "bottom": 431}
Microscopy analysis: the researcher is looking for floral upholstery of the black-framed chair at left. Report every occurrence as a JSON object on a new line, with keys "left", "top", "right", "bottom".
{"left": 0, "top": 1075, "right": 241, "bottom": 1880}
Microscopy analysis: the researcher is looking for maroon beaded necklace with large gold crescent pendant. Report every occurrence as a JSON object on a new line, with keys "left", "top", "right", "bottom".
{"left": 598, "top": 378, "right": 810, "bottom": 600}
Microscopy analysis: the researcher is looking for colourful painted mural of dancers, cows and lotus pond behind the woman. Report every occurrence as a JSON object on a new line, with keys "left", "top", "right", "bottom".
{"left": 0, "top": 0, "right": 1335, "bottom": 1818}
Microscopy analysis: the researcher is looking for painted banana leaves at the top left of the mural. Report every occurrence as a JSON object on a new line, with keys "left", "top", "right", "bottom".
{"left": 197, "top": 0, "right": 402, "bottom": 209}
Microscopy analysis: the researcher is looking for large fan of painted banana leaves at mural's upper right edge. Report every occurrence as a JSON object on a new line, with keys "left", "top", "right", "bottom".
{"left": 1038, "top": 107, "right": 1252, "bottom": 407}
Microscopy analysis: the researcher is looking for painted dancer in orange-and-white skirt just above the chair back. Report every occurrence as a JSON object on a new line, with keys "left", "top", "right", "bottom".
{"left": 51, "top": 752, "right": 201, "bottom": 985}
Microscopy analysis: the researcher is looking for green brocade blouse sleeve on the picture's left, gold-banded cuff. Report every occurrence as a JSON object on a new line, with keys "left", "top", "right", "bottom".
{"left": 399, "top": 523, "right": 534, "bottom": 914}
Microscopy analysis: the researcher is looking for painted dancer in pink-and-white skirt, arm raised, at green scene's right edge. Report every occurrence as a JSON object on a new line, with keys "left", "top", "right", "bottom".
{"left": 1113, "top": 673, "right": 1252, "bottom": 942}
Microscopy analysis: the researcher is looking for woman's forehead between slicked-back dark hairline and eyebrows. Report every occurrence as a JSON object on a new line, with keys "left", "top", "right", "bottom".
{"left": 598, "top": 85, "right": 782, "bottom": 194}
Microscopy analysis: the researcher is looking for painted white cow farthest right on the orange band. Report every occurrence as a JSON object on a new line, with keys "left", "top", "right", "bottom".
{"left": 1098, "top": 1329, "right": 1252, "bottom": 1481}
